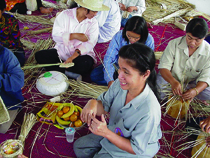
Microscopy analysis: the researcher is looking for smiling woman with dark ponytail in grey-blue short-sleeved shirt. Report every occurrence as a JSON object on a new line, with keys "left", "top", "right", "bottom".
{"left": 74, "top": 43, "right": 162, "bottom": 158}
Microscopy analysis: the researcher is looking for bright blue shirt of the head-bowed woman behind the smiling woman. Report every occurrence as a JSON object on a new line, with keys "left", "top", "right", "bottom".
{"left": 103, "top": 30, "right": 154, "bottom": 84}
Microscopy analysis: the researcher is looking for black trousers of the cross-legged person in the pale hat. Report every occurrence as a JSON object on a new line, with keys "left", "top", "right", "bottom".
{"left": 35, "top": 48, "right": 94, "bottom": 75}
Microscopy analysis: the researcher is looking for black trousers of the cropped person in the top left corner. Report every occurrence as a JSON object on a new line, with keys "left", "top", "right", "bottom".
{"left": 10, "top": 0, "right": 43, "bottom": 14}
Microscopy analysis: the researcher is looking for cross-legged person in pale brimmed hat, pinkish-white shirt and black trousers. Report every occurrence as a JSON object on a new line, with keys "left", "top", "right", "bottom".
{"left": 35, "top": 0, "right": 109, "bottom": 79}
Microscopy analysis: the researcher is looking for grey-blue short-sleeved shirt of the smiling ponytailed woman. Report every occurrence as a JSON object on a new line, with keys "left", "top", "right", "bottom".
{"left": 98, "top": 79, "right": 162, "bottom": 158}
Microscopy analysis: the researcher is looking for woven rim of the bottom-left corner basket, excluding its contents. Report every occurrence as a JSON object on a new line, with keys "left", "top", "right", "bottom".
{"left": 0, "top": 139, "right": 23, "bottom": 158}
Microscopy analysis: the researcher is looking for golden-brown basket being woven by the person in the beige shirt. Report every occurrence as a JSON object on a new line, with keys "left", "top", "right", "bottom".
{"left": 167, "top": 97, "right": 190, "bottom": 119}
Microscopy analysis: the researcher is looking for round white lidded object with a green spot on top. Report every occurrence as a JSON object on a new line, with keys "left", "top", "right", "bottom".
{"left": 36, "top": 71, "right": 69, "bottom": 96}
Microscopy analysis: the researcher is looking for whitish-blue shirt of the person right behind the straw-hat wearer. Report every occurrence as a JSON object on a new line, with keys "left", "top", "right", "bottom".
{"left": 96, "top": 0, "right": 121, "bottom": 43}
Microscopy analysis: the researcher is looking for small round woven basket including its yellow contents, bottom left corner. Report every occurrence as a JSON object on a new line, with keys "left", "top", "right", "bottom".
{"left": 0, "top": 139, "right": 23, "bottom": 158}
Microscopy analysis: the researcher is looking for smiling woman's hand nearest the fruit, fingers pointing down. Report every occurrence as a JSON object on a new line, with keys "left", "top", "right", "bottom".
{"left": 80, "top": 99, "right": 97, "bottom": 126}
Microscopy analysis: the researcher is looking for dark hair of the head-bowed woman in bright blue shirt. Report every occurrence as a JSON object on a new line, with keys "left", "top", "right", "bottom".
{"left": 122, "top": 16, "right": 149, "bottom": 44}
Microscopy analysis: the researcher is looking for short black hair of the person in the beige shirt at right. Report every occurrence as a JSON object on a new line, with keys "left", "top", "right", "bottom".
{"left": 186, "top": 18, "right": 208, "bottom": 39}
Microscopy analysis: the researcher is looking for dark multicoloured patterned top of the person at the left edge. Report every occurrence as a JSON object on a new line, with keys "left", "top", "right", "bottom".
{"left": 0, "top": 13, "right": 22, "bottom": 49}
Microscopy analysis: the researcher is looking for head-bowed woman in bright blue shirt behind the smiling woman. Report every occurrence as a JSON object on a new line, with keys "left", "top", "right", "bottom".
{"left": 90, "top": 16, "right": 154, "bottom": 87}
